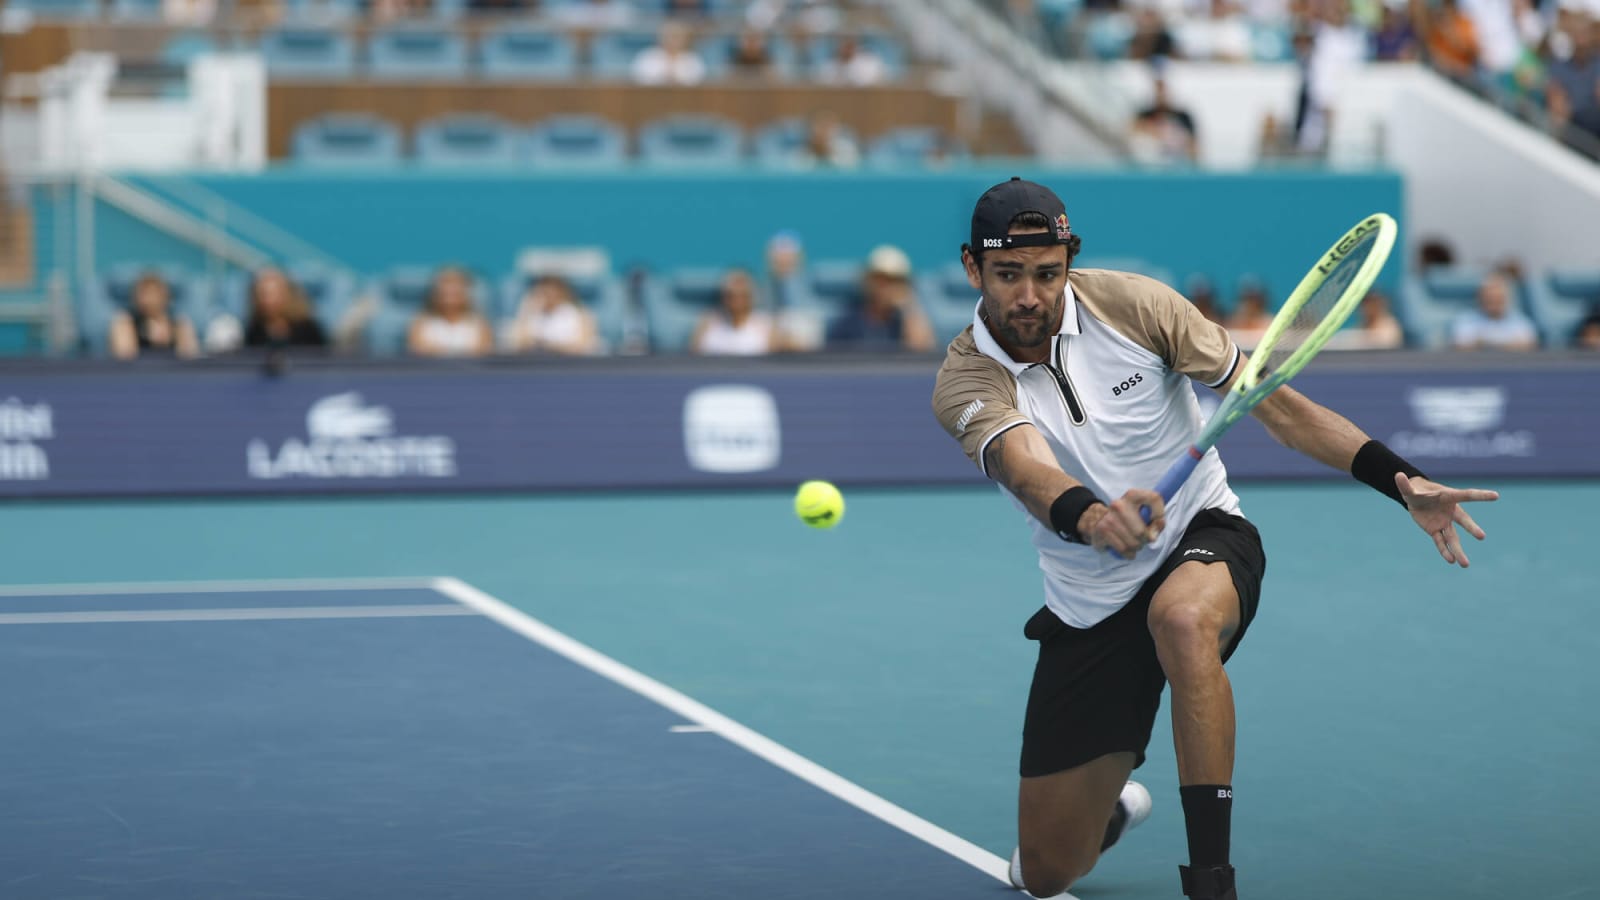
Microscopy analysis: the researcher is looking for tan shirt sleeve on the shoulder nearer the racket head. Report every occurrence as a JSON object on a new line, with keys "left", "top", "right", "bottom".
{"left": 1072, "top": 269, "right": 1238, "bottom": 388}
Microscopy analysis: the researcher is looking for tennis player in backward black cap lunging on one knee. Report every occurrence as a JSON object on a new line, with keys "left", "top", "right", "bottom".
{"left": 933, "top": 178, "right": 1498, "bottom": 900}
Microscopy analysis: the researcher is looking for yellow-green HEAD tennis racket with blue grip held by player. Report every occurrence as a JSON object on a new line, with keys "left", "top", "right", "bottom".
{"left": 1141, "top": 213, "right": 1400, "bottom": 522}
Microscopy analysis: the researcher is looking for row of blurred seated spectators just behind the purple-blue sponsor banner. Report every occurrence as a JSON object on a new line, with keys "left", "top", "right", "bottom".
{"left": 107, "top": 232, "right": 1600, "bottom": 359}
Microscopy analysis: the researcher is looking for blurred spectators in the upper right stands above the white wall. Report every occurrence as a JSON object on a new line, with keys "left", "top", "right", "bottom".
{"left": 994, "top": 0, "right": 1600, "bottom": 157}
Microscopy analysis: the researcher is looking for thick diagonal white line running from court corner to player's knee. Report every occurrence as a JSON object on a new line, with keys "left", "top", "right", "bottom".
{"left": 434, "top": 578, "right": 1011, "bottom": 883}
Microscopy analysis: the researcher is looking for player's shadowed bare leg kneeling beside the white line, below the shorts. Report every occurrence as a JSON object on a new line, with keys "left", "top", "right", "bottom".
{"left": 1018, "top": 753, "right": 1134, "bottom": 897}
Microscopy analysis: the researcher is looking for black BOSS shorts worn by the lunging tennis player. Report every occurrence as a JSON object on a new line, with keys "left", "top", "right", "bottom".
{"left": 1022, "top": 509, "right": 1267, "bottom": 778}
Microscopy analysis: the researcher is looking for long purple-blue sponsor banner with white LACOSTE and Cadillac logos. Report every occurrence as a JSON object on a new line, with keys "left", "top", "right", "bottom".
{"left": 0, "top": 364, "right": 1600, "bottom": 496}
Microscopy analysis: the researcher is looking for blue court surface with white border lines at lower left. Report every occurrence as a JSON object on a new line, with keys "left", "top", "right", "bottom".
{"left": 0, "top": 578, "right": 1002, "bottom": 900}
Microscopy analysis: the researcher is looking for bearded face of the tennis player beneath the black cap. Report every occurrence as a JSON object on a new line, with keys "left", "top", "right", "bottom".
{"left": 966, "top": 232, "right": 1067, "bottom": 349}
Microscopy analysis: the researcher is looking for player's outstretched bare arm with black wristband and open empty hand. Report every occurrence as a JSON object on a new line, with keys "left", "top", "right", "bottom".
{"left": 1218, "top": 375, "right": 1499, "bottom": 569}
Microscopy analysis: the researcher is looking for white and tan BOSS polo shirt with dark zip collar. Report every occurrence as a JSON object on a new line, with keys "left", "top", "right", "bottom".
{"left": 933, "top": 269, "right": 1240, "bottom": 628}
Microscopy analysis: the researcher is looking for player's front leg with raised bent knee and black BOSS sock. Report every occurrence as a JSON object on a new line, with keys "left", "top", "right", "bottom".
{"left": 1149, "top": 562, "right": 1240, "bottom": 898}
